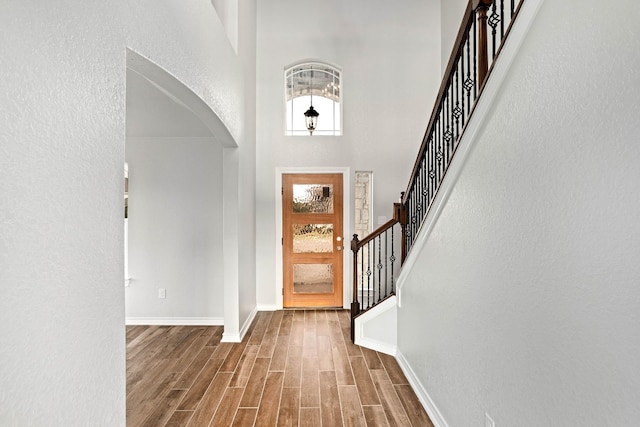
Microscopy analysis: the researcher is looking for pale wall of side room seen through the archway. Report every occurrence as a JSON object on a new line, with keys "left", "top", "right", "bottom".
{"left": 125, "top": 138, "right": 224, "bottom": 324}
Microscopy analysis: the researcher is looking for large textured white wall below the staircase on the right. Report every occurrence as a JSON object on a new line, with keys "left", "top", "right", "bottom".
{"left": 398, "top": 0, "right": 640, "bottom": 426}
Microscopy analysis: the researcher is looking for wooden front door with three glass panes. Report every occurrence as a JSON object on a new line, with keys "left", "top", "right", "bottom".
{"left": 282, "top": 174, "right": 344, "bottom": 307}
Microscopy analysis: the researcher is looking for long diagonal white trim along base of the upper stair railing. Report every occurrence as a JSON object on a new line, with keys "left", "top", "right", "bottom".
{"left": 396, "top": 0, "right": 544, "bottom": 307}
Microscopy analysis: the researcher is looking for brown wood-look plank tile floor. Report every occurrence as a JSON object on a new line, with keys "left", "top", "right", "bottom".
{"left": 127, "top": 310, "right": 432, "bottom": 427}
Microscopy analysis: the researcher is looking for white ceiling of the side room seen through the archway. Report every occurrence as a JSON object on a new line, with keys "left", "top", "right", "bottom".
{"left": 126, "top": 69, "right": 211, "bottom": 137}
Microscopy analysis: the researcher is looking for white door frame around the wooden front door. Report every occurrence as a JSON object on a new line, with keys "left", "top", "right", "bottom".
{"left": 274, "top": 167, "right": 353, "bottom": 310}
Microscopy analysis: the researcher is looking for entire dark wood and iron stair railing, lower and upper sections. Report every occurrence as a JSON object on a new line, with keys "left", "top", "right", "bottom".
{"left": 351, "top": 0, "right": 524, "bottom": 340}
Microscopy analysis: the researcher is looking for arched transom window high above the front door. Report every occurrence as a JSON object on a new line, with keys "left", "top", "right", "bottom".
{"left": 285, "top": 62, "right": 342, "bottom": 136}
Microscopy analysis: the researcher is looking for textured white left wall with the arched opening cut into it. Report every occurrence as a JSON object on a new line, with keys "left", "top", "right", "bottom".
{"left": 0, "top": 0, "right": 255, "bottom": 426}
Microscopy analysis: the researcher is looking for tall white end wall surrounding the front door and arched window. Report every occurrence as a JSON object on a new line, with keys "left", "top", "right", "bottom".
{"left": 256, "top": 0, "right": 440, "bottom": 306}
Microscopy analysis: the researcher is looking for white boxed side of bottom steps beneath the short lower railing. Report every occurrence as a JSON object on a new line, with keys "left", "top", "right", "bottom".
{"left": 354, "top": 295, "right": 398, "bottom": 357}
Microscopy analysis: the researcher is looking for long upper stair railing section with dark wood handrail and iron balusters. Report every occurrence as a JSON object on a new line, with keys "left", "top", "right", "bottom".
{"left": 402, "top": 0, "right": 524, "bottom": 253}
